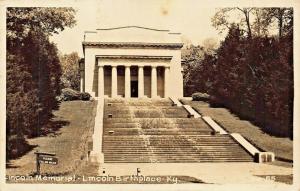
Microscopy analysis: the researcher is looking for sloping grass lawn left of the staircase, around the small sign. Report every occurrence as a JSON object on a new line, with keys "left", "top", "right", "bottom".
{"left": 6, "top": 101, "right": 97, "bottom": 182}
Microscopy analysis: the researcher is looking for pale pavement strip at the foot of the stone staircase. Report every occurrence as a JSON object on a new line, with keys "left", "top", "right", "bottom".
{"left": 99, "top": 162, "right": 293, "bottom": 185}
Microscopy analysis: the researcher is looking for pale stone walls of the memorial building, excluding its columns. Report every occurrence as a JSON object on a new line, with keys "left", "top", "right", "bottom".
{"left": 82, "top": 26, "right": 183, "bottom": 97}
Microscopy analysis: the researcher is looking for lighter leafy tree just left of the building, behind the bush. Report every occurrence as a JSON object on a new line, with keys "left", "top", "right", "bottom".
{"left": 59, "top": 52, "right": 80, "bottom": 90}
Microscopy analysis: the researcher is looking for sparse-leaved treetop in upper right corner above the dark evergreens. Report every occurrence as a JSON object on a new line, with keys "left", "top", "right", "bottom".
{"left": 211, "top": 7, "right": 293, "bottom": 38}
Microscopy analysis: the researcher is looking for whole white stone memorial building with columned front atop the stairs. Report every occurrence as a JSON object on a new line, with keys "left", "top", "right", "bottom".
{"left": 80, "top": 26, "right": 183, "bottom": 98}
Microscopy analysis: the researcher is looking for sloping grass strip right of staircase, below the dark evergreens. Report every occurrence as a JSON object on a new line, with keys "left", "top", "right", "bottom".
{"left": 181, "top": 99, "right": 293, "bottom": 164}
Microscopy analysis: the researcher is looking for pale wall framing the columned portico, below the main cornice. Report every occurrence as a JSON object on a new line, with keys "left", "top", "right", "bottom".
{"left": 85, "top": 47, "right": 183, "bottom": 97}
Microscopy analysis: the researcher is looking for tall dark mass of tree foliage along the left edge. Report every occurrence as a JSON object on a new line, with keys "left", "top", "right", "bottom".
{"left": 6, "top": 7, "right": 75, "bottom": 158}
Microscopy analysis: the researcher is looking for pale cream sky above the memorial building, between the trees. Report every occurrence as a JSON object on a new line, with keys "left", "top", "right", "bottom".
{"left": 51, "top": 0, "right": 223, "bottom": 56}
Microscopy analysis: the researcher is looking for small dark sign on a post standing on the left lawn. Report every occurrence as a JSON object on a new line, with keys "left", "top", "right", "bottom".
{"left": 34, "top": 151, "right": 58, "bottom": 175}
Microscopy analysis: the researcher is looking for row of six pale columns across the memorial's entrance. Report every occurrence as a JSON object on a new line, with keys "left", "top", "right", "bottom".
{"left": 98, "top": 65, "right": 170, "bottom": 98}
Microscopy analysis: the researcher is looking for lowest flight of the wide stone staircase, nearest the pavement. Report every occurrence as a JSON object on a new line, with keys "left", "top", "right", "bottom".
{"left": 103, "top": 136, "right": 253, "bottom": 162}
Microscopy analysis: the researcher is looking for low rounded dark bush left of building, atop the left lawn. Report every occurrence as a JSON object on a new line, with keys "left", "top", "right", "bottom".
{"left": 57, "top": 88, "right": 91, "bottom": 101}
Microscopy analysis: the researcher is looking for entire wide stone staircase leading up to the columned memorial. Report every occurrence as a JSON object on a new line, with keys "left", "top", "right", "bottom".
{"left": 102, "top": 99, "right": 253, "bottom": 163}
